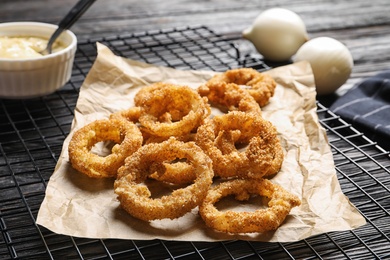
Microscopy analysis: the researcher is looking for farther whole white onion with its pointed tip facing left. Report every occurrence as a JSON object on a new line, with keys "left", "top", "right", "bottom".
{"left": 242, "top": 8, "right": 308, "bottom": 61}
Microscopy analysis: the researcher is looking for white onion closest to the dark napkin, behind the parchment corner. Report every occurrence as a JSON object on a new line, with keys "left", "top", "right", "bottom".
{"left": 293, "top": 37, "right": 354, "bottom": 95}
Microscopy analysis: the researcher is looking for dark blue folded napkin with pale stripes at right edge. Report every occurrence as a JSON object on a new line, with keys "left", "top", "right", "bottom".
{"left": 330, "top": 70, "right": 390, "bottom": 150}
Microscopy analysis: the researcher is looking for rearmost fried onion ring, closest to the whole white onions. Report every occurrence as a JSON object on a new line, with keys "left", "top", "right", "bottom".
{"left": 206, "top": 68, "right": 276, "bottom": 107}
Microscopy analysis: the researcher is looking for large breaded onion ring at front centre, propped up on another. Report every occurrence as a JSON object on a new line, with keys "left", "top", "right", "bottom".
{"left": 114, "top": 137, "right": 213, "bottom": 221}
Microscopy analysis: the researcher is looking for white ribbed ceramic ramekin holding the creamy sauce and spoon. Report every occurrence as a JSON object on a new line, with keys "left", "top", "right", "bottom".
{"left": 0, "top": 22, "right": 77, "bottom": 99}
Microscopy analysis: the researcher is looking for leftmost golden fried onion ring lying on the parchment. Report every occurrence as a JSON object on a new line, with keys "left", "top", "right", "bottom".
{"left": 68, "top": 119, "right": 142, "bottom": 178}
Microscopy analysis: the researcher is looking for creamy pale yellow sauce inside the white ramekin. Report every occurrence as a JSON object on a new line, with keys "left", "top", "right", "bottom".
{"left": 0, "top": 36, "right": 66, "bottom": 59}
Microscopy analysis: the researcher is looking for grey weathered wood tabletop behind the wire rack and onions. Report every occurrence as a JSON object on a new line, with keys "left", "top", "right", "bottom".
{"left": 0, "top": 0, "right": 390, "bottom": 94}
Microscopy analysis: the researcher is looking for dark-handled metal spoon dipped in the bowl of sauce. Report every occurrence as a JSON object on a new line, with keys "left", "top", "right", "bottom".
{"left": 39, "top": 0, "right": 96, "bottom": 55}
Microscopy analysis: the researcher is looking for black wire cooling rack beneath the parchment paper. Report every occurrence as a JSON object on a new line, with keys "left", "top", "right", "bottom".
{"left": 0, "top": 26, "right": 390, "bottom": 259}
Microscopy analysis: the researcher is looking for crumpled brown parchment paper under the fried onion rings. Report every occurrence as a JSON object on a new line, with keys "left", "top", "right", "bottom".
{"left": 37, "top": 43, "right": 365, "bottom": 242}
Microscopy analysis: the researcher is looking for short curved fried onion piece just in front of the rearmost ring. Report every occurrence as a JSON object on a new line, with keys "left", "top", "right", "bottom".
{"left": 198, "top": 81, "right": 261, "bottom": 114}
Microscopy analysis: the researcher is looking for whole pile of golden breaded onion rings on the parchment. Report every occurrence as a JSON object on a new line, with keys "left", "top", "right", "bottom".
{"left": 69, "top": 69, "right": 300, "bottom": 233}
